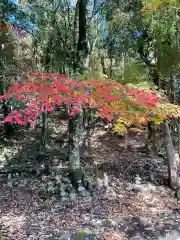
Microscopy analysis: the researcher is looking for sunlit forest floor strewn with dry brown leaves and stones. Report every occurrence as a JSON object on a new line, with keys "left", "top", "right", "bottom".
{"left": 0, "top": 113, "right": 180, "bottom": 240}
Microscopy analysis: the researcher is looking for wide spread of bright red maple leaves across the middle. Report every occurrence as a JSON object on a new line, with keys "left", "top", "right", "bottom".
{"left": 0, "top": 72, "right": 159, "bottom": 125}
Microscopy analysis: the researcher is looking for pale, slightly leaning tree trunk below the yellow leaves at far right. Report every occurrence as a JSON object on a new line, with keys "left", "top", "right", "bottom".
{"left": 164, "top": 122, "right": 178, "bottom": 189}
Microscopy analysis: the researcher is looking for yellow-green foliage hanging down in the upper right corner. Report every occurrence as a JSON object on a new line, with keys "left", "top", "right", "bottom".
{"left": 142, "top": 0, "right": 180, "bottom": 76}
